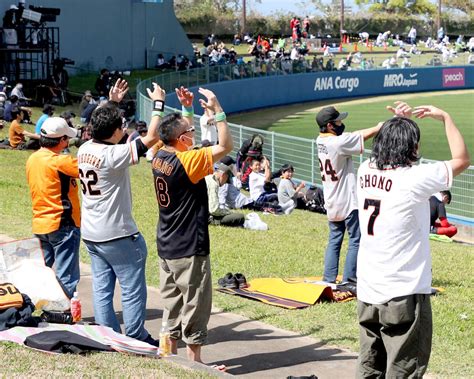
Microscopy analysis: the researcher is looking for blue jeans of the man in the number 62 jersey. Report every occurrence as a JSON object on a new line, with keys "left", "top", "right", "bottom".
{"left": 84, "top": 233, "right": 149, "bottom": 340}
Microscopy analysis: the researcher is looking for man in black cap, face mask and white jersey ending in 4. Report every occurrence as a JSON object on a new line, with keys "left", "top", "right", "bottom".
{"left": 316, "top": 107, "right": 381, "bottom": 283}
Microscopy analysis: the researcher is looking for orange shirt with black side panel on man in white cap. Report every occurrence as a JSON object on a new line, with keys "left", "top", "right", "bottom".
{"left": 26, "top": 148, "right": 81, "bottom": 234}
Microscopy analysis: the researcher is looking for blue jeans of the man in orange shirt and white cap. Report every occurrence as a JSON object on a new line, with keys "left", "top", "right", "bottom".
{"left": 35, "top": 226, "right": 81, "bottom": 298}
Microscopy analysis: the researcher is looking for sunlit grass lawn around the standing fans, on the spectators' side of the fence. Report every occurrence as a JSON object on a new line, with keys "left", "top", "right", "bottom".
{"left": 0, "top": 115, "right": 474, "bottom": 378}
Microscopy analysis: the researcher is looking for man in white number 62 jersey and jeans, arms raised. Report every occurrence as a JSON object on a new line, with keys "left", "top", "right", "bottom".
{"left": 77, "top": 80, "right": 165, "bottom": 345}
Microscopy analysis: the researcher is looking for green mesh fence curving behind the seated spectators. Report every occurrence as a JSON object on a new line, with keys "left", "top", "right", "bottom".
{"left": 137, "top": 66, "right": 474, "bottom": 225}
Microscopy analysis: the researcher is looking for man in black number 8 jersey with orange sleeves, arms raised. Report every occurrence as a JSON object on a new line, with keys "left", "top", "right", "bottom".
{"left": 152, "top": 87, "right": 233, "bottom": 362}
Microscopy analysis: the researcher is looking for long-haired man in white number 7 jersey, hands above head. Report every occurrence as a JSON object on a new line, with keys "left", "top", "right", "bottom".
{"left": 357, "top": 103, "right": 469, "bottom": 378}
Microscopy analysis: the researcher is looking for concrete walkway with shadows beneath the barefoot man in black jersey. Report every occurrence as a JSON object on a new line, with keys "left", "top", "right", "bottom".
{"left": 79, "top": 264, "right": 357, "bottom": 379}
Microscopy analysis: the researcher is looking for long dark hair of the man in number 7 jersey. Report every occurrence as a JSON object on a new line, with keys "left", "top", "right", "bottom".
{"left": 371, "top": 117, "right": 420, "bottom": 170}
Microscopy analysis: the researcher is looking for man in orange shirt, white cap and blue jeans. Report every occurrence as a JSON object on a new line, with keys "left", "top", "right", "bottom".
{"left": 26, "top": 117, "right": 81, "bottom": 298}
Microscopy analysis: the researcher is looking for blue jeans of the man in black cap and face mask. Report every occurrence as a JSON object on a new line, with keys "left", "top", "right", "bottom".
{"left": 323, "top": 209, "right": 360, "bottom": 282}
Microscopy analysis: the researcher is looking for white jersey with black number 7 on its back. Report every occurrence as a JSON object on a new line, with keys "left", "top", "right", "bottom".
{"left": 357, "top": 161, "right": 453, "bottom": 304}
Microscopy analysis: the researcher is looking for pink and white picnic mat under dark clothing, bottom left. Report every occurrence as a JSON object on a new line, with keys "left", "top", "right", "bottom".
{"left": 0, "top": 324, "right": 158, "bottom": 357}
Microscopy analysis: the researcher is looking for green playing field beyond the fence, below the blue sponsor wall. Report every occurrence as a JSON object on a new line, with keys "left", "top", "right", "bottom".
{"left": 229, "top": 90, "right": 474, "bottom": 160}
